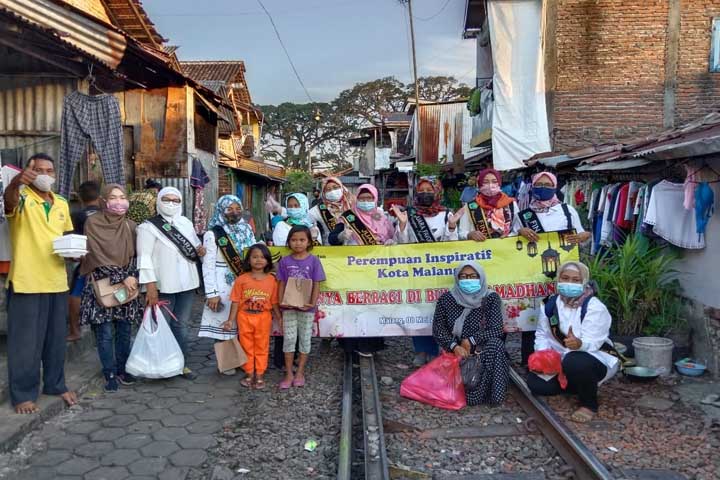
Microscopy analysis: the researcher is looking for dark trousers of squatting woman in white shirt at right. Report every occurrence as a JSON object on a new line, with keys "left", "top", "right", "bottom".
{"left": 527, "top": 352, "right": 607, "bottom": 412}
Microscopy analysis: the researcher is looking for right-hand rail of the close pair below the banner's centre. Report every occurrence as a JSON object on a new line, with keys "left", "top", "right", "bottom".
{"left": 360, "top": 354, "right": 390, "bottom": 480}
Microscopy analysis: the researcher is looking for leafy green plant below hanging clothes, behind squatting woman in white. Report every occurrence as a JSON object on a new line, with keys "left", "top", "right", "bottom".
{"left": 589, "top": 235, "right": 684, "bottom": 335}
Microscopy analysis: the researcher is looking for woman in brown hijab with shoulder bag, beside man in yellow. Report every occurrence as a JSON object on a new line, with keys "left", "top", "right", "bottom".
{"left": 80, "top": 183, "right": 142, "bottom": 392}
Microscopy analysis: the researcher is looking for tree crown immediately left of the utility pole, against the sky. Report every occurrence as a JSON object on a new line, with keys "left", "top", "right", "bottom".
{"left": 333, "top": 77, "right": 407, "bottom": 126}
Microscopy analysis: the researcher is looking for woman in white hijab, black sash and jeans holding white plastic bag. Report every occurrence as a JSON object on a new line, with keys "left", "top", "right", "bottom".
{"left": 137, "top": 187, "right": 205, "bottom": 380}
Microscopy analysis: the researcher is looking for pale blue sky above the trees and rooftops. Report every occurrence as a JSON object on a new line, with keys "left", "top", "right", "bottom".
{"left": 143, "top": 0, "right": 475, "bottom": 105}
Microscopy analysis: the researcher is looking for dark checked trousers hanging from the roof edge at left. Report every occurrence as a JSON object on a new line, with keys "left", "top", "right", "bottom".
{"left": 58, "top": 92, "right": 125, "bottom": 198}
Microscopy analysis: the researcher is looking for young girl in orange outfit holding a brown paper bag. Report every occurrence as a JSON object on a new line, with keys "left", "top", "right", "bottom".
{"left": 223, "top": 243, "right": 280, "bottom": 390}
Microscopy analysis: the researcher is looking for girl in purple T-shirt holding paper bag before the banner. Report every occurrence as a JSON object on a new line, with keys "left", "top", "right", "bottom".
{"left": 278, "top": 225, "right": 325, "bottom": 390}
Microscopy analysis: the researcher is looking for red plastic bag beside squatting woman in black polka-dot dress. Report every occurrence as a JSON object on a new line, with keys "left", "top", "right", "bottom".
{"left": 400, "top": 352, "right": 467, "bottom": 410}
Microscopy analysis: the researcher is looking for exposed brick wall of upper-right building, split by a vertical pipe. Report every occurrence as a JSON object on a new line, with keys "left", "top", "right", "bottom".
{"left": 549, "top": 0, "right": 720, "bottom": 150}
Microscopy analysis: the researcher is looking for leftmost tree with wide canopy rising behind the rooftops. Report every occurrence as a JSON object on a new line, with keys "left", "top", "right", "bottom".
{"left": 260, "top": 103, "right": 355, "bottom": 170}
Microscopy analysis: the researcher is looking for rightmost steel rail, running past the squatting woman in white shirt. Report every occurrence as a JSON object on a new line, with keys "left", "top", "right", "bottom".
{"left": 510, "top": 368, "right": 614, "bottom": 480}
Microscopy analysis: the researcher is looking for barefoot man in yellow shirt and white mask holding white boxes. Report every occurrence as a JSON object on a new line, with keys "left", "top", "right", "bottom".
{"left": 5, "top": 153, "right": 77, "bottom": 413}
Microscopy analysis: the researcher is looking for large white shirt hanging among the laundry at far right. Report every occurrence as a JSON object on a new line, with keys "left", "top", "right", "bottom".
{"left": 645, "top": 180, "right": 705, "bottom": 249}
